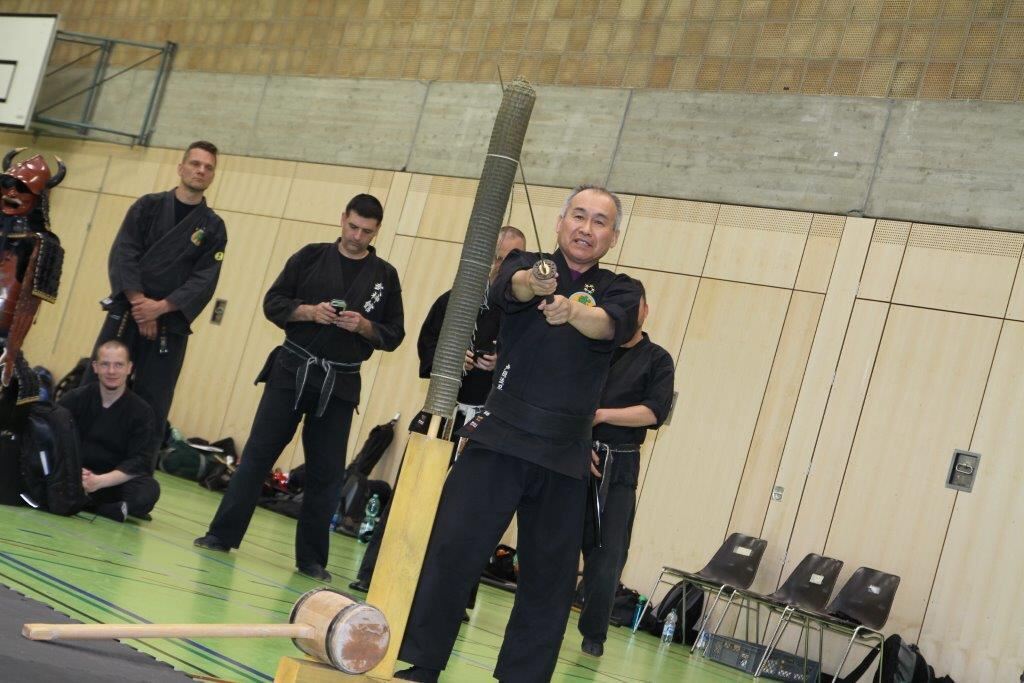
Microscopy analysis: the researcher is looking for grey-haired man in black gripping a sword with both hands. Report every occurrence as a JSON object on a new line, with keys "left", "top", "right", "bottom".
{"left": 395, "top": 185, "right": 640, "bottom": 682}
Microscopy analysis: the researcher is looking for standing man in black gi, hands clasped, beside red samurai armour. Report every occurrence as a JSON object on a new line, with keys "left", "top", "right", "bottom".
{"left": 85, "top": 140, "right": 227, "bottom": 455}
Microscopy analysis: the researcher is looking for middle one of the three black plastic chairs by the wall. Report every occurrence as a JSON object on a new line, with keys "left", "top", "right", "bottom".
{"left": 741, "top": 553, "right": 843, "bottom": 678}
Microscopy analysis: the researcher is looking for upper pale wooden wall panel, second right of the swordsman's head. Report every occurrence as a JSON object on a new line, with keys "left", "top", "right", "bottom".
{"left": 703, "top": 205, "right": 811, "bottom": 288}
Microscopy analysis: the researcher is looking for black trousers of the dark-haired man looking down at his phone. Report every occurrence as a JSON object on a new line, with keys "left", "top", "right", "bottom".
{"left": 203, "top": 386, "right": 355, "bottom": 567}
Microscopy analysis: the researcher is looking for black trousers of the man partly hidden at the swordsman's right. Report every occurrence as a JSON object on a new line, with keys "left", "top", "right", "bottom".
{"left": 579, "top": 454, "right": 639, "bottom": 643}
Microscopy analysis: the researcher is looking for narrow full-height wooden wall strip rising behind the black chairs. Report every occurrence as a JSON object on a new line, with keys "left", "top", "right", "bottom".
{"left": 755, "top": 218, "right": 873, "bottom": 591}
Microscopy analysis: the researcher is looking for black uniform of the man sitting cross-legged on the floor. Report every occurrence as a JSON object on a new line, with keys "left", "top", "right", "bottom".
{"left": 59, "top": 382, "right": 160, "bottom": 517}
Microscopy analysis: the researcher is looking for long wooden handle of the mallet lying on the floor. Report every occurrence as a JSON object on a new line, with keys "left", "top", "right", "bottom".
{"left": 22, "top": 624, "right": 316, "bottom": 640}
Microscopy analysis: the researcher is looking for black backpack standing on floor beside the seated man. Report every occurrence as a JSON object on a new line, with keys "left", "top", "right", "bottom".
{"left": 22, "top": 401, "right": 88, "bottom": 515}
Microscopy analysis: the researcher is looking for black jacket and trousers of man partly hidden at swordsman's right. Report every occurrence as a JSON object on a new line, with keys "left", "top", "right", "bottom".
{"left": 579, "top": 333, "right": 675, "bottom": 643}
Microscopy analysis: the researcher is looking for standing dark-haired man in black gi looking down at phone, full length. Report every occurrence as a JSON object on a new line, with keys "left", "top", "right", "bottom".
{"left": 196, "top": 195, "right": 406, "bottom": 582}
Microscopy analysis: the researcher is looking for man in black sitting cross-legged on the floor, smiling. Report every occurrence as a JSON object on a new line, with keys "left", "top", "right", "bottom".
{"left": 60, "top": 339, "right": 160, "bottom": 522}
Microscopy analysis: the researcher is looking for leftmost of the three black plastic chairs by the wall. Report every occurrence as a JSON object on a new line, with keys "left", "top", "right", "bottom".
{"left": 634, "top": 533, "right": 768, "bottom": 651}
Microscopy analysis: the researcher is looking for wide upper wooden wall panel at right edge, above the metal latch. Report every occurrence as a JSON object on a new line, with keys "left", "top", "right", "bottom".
{"left": 893, "top": 223, "right": 1024, "bottom": 317}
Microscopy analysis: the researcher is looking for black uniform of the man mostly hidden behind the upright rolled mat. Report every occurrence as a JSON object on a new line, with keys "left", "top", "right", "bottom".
{"left": 356, "top": 290, "right": 502, "bottom": 589}
